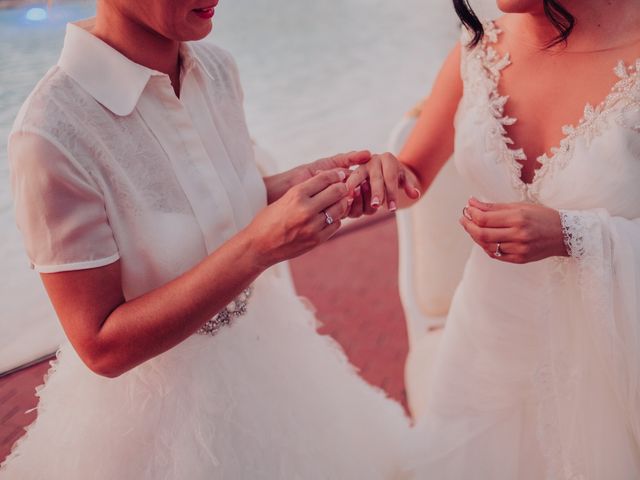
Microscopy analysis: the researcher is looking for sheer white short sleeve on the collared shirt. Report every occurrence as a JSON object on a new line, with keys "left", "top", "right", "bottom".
{"left": 9, "top": 131, "right": 120, "bottom": 273}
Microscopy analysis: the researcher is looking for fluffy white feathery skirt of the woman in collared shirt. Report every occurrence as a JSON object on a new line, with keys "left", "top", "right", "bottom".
{"left": 0, "top": 274, "right": 409, "bottom": 480}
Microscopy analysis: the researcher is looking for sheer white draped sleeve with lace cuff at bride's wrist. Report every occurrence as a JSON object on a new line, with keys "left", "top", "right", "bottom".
{"left": 560, "top": 209, "right": 640, "bottom": 445}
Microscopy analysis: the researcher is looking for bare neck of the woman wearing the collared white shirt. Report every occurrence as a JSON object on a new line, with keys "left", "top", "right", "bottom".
{"left": 91, "top": 2, "right": 180, "bottom": 86}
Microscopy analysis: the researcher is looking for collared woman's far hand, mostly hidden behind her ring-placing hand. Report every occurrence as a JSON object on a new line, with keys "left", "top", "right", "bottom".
{"left": 264, "top": 150, "right": 371, "bottom": 204}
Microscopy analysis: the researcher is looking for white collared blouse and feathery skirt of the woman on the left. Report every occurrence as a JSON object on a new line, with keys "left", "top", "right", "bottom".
{"left": 0, "top": 20, "right": 408, "bottom": 480}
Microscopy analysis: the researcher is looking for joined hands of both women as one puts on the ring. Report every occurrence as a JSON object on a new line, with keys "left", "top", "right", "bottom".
{"left": 252, "top": 151, "right": 421, "bottom": 268}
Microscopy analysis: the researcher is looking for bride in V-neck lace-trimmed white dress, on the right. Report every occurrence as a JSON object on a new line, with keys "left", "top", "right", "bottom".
{"left": 350, "top": 0, "right": 640, "bottom": 480}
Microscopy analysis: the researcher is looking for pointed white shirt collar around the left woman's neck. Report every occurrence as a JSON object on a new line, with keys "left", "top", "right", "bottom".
{"left": 58, "top": 18, "right": 211, "bottom": 116}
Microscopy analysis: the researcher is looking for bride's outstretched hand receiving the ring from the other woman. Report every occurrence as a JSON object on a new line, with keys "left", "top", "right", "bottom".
{"left": 347, "top": 153, "right": 422, "bottom": 217}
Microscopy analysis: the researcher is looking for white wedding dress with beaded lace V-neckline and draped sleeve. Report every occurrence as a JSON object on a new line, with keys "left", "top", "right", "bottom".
{"left": 408, "top": 23, "right": 640, "bottom": 480}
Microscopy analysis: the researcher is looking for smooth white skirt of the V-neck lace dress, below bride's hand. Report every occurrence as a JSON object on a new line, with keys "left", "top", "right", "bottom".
{"left": 406, "top": 247, "right": 640, "bottom": 480}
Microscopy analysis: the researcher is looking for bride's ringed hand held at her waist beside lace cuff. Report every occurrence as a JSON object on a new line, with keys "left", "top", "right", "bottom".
{"left": 460, "top": 198, "right": 568, "bottom": 264}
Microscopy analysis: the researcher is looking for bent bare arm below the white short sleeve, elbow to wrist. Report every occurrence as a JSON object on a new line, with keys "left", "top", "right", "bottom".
{"left": 41, "top": 232, "right": 262, "bottom": 377}
